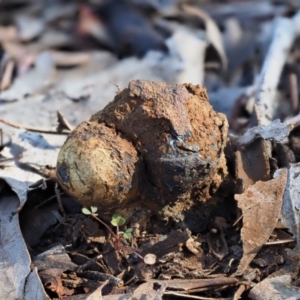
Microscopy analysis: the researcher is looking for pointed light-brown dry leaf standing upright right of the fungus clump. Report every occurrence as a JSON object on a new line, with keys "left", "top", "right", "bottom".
{"left": 235, "top": 169, "right": 287, "bottom": 274}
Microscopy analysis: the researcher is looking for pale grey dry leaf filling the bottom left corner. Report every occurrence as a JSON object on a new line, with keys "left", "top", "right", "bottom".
{"left": 0, "top": 196, "right": 49, "bottom": 299}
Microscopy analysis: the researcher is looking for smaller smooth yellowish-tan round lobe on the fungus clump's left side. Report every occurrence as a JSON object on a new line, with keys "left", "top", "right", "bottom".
{"left": 57, "top": 122, "right": 142, "bottom": 218}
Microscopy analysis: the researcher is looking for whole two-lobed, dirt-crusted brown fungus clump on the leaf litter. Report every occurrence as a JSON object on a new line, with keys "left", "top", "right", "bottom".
{"left": 57, "top": 80, "right": 228, "bottom": 223}
